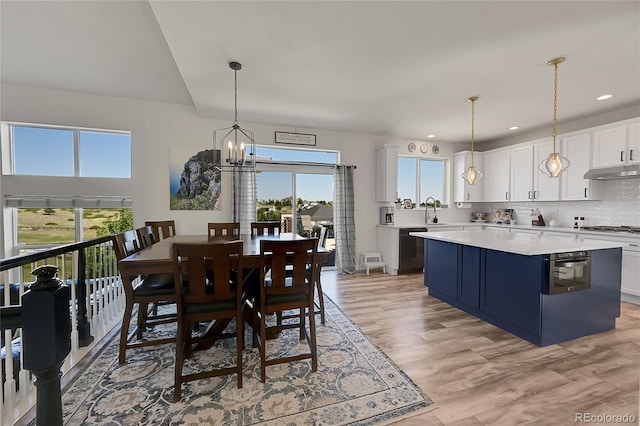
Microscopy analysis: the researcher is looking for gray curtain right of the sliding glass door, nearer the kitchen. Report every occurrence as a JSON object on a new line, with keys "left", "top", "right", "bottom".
{"left": 333, "top": 166, "right": 356, "bottom": 274}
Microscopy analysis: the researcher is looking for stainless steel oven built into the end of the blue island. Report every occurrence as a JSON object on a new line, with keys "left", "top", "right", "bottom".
{"left": 545, "top": 251, "right": 591, "bottom": 294}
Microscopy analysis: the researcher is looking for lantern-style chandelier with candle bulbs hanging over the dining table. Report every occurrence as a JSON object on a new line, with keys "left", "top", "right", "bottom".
{"left": 213, "top": 61, "right": 256, "bottom": 171}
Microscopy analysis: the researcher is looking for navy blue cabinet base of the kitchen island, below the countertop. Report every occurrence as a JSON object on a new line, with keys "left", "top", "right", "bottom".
{"left": 424, "top": 239, "right": 622, "bottom": 346}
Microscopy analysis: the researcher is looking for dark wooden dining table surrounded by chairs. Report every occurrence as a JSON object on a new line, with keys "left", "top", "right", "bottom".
{"left": 118, "top": 233, "right": 329, "bottom": 350}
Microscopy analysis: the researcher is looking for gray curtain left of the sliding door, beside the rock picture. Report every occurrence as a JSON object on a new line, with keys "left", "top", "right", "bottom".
{"left": 232, "top": 167, "right": 257, "bottom": 235}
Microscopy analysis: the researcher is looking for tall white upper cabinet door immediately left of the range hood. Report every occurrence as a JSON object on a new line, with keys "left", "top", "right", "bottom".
{"left": 560, "top": 131, "right": 593, "bottom": 200}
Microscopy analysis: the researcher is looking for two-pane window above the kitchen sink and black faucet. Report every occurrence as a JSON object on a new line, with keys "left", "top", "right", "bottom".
{"left": 398, "top": 156, "right": 448, "bottom": 206}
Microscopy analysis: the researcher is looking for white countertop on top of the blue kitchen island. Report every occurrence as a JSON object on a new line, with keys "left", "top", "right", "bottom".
{"left": 409, "top": 229, "right": 628, "bottom": 256}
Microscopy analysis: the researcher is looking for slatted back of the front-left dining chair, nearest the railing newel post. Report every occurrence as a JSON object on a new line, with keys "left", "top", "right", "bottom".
{"left": 172, "top": 241, "right": 243, "bottom": 304}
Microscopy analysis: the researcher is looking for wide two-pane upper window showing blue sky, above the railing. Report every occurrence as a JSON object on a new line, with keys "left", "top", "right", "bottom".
{"left": 5, "top": 124, "right": 131, "bottom": 178}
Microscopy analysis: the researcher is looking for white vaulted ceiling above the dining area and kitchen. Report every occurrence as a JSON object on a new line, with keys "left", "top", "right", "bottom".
{"left": 0, "top": 0, "right": 640, "bottom": 142}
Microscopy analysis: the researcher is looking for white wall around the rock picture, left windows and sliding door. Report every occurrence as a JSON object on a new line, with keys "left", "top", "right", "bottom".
{"left": 0, "top": 84, "right": 459, "bottom": 262}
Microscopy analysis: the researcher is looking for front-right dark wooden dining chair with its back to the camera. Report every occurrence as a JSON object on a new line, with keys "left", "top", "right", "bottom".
{"left": 248, "top": 239, "right": 318, "bottom": 382}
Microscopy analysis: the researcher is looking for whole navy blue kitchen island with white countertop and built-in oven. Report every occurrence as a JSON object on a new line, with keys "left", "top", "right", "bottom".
{"left": 411, "top": 230, "right": 625, "bottom": 346}
